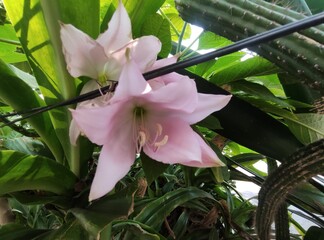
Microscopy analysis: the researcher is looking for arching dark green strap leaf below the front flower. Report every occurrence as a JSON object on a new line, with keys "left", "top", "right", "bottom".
{"left": 134, "top": 187, "right": 215, "bottom": 230}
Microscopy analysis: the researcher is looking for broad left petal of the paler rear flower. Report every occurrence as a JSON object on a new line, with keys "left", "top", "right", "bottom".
{"left": 60, "top": 24, "right": 107, "bottom": 79}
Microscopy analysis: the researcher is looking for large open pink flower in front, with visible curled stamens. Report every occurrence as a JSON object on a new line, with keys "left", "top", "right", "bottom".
{"left": 71, "top": 60, "right": 231, "bottom": 200}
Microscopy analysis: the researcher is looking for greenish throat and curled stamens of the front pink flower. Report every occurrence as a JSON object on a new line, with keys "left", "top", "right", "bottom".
{"left": 133, "top": 107, "right": 169, "bottom": 154}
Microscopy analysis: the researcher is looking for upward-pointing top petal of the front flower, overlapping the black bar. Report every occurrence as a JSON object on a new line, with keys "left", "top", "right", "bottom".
{"left": 111, "top": 60, "right": 151, "bottom": 103}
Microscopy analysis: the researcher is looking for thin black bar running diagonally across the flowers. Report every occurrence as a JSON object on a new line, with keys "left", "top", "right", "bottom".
{"left": 0, "top": 12, "right": 324, "bottom": 127}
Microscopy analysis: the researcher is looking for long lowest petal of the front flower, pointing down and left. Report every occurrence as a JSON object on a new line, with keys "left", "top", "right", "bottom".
{"left": 89, "top": 125, "right": 135, "bottom": 201}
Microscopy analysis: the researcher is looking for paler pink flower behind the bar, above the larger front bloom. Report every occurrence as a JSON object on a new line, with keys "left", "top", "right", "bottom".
{"left": 60, "top": 1, "right": 161, "bottom": 145}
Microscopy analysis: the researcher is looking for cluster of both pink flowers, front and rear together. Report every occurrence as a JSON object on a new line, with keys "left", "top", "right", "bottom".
{"left": 61, "top": 2, "right": 231, "bottom": 201}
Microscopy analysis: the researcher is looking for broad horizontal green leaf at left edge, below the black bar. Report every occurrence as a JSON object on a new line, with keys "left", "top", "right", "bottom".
{"left": 0, "top": 150, "right": 77, "bottom": 195}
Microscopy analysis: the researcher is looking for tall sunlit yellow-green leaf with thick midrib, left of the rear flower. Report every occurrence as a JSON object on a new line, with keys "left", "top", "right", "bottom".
{"left": 4, "top": 0, "right": 99, "bottom": 175}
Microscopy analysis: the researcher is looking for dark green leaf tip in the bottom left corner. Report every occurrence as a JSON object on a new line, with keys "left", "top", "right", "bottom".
{"left": 0, "top": 223, "right": 48, "bottom": 240}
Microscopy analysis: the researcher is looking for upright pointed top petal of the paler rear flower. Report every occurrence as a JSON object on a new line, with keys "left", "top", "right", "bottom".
{"left": 97, "top": 1, "right": 132, "bottom": 55}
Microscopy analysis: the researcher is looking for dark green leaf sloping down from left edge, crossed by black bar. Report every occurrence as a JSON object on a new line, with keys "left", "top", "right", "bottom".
{"left": 0, "top": 60, "right": 63, "bottom": 161}
